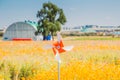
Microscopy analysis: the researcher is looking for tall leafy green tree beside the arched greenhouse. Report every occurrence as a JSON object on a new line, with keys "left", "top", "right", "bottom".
{"left": 37, "top": 2, "right": 66, "bottom": 40}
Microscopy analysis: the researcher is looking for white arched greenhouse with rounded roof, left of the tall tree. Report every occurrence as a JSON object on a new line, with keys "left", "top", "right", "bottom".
{"left": 3, "top": 21, "right": 37, "bottom": 40}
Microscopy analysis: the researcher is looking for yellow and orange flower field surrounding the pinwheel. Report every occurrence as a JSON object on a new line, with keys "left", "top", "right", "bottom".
{"left": 0, "top": 37, "right": 120, "bottom": 80}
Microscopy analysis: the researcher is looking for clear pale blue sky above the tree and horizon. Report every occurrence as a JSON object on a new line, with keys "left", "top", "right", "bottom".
{"left": 0, "top": 0, "right": 120, "bottom": 28}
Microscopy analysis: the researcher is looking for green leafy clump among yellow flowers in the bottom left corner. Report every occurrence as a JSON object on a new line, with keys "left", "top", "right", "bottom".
{"left": 0, "top": 60, "right": 36, "bottom": 80}
